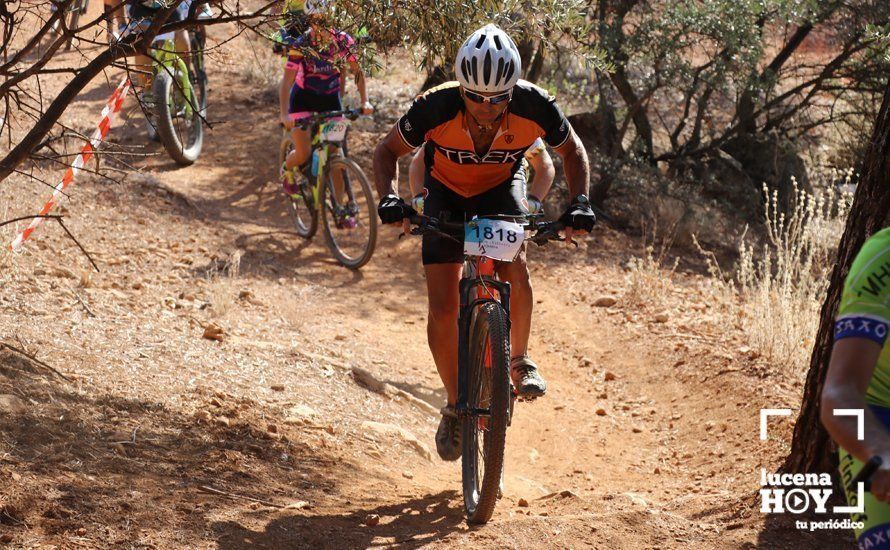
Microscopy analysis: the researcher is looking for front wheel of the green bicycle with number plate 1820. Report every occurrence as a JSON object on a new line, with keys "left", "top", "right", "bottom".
{"left": 321, "top": 157, "right": 377, "bottom": 269}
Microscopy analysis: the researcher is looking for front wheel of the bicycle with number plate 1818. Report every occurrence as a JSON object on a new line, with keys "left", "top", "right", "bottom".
{"left": 461, "top": 301, "right": 510, "bottom": 524}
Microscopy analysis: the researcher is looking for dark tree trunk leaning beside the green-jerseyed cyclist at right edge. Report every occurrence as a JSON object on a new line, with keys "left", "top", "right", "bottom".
{"left": 780, "top": 76, "right": 890, "bottom": 473}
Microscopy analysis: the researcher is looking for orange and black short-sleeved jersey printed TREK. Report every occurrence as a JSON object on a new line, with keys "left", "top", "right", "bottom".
{"left": 398, "top": 80, "right": 571, "bottom": 197}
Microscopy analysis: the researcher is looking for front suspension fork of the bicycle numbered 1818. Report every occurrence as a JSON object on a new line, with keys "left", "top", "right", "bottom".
{"left": 455, "top": 276, "right": 513, "bottom": 425}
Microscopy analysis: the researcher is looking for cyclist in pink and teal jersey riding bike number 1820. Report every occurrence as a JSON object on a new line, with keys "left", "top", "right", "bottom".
{"left": 279, "top": 0, "right": 374, "bottom": 196}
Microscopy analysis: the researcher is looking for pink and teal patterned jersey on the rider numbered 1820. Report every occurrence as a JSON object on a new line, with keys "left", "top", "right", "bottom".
{"left": 285, "top": 29, "right": 356, "bottom": 95}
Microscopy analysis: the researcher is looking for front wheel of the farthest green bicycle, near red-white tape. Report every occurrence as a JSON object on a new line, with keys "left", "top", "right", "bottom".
{"left": 152, "top": 66, "right": 206, "bottom": 166}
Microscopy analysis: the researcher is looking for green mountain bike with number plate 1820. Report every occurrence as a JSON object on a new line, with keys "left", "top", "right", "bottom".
{"left": 279, "top": 110, "right": 377, "bottom": 269}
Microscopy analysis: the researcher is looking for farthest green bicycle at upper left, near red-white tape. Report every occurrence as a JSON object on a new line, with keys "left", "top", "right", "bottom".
{"left": 149, "top": 28, "right": 207, "bottom": 166}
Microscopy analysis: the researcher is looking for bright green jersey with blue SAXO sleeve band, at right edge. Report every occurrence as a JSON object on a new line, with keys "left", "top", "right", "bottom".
{"left": 834, "top": 227, "right": 890, "bottom": 407}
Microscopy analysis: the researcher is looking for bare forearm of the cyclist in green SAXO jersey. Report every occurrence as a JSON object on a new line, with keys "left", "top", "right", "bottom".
{"left": 821, "top": 387, "right": 890, "bottom": 462}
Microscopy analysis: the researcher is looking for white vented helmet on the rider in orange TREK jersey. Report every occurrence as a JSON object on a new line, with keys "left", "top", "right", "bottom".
{"left": 454, "top": 23, "right": 522, "bottom": 92}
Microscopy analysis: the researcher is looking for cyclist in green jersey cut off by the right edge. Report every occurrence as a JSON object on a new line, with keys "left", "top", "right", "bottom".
{"left": 821, "top": 227, "right": 890, "bottom": 549}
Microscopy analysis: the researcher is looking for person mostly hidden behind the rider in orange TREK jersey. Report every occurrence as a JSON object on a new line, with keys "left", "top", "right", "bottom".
{"left": 408, "top": 138, "right": 556, "bottom": 218}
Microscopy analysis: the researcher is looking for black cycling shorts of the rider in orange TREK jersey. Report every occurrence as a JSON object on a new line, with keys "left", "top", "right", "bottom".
{"left": 422, "top": 167, "right": 528, "bottom": 265}
